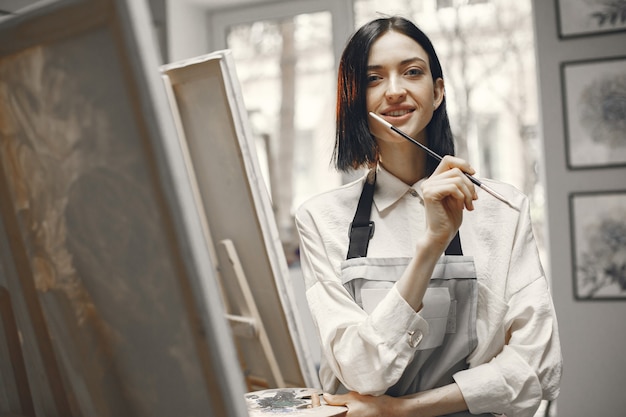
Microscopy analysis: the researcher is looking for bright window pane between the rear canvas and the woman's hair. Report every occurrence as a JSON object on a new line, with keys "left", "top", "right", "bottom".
{"left": 227, "top": 12, "right": 341, "bottom": 261}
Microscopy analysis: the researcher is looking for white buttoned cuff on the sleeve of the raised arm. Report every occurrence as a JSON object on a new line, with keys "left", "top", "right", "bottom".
{"left": 370, "top": 285, "right": 428, "bottom": 353}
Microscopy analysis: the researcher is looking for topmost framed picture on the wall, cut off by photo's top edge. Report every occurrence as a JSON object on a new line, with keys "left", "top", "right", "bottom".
{"left": 555, "top": 0, "right": 626, "bottom": 38}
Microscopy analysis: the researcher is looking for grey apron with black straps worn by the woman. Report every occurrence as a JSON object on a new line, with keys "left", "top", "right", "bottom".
{"left": 341, "top": 171, "right": 482, "bottom": 416}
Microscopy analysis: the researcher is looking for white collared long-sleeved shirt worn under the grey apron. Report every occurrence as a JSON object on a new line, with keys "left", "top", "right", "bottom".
{"left": 296, "top": 166, "right": 562, "bottom": 417}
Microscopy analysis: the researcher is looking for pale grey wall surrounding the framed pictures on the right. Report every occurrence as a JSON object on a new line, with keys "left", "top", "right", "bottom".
{"left": 533, "top": 0, "right": 626, "bottom": 417}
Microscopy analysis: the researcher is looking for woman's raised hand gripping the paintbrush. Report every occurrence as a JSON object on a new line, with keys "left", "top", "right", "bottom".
{"left": 422, "top": 155, "right": 478, "bottom": 251}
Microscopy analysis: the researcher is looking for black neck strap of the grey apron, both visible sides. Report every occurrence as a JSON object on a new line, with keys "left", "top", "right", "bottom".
{"left": 346, "top": 170, "right": 463, "bottom": 259}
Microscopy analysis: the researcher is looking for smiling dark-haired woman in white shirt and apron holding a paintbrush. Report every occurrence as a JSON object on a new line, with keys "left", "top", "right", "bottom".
{"left": 296, "top": 17, "right": 561, "bottom": 417}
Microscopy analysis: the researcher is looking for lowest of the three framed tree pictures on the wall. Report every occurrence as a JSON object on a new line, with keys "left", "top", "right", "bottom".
{"left": 569, "top": 190, "right": 626, "bottom": 300}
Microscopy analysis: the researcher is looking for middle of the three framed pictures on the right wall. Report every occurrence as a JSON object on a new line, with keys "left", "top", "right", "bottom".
{"left": 561, "top": 57, "right": 626, "bottom": 169}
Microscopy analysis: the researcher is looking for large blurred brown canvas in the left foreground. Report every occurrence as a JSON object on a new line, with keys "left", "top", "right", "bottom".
{"left": 0, "top": 0, "right": 248, "bottom": 417}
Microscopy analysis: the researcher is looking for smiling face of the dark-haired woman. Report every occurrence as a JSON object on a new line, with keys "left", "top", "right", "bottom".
{"left": 366, "top": 31, "right": 444, "bottom": 144}
